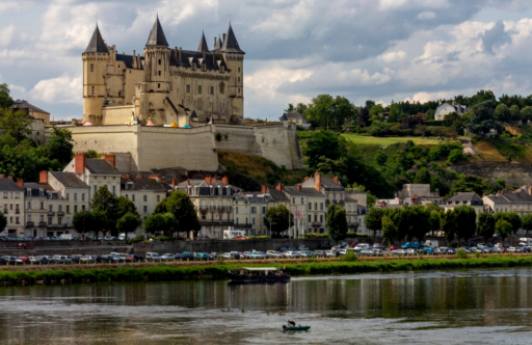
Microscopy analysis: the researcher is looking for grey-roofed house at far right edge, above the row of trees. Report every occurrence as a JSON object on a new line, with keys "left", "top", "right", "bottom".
{"left": 482, "top": 185, "right": 532, "bottom": 215}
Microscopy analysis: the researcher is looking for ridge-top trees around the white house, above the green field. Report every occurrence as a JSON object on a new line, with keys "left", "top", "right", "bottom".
{"left": 286, "top": 90, "right": 532, "bottom": 136}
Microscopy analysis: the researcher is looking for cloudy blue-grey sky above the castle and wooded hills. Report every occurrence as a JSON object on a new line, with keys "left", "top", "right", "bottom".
{"left": 0, "top": 0, "right": 532, "bottom": 119}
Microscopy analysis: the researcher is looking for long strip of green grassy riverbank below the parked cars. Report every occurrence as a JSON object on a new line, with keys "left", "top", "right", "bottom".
{"left": 0, "top": 255, "right": 532, "bottom": 286}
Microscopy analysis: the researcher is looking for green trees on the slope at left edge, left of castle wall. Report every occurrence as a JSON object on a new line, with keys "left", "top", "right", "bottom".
{"left": 0, "top": 84, "right": 73, "bottom": 181}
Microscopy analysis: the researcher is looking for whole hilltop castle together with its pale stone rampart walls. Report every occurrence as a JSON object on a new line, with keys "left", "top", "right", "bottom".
{"left": 68, "top": 18, "right": 302, "bottom": 173}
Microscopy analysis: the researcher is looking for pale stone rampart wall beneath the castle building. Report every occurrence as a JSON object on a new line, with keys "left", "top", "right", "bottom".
{"left": 68, "top": 125, "right": 301, "bottom": 171}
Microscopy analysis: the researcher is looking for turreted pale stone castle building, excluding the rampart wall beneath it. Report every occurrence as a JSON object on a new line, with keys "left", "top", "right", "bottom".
{"left": 82, "top": 17, "right": 245, "bottom": 128}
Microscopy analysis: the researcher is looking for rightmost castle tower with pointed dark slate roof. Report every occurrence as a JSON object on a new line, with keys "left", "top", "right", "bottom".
{"left": 220, "top": 24, "right": 245, "bottom": 121}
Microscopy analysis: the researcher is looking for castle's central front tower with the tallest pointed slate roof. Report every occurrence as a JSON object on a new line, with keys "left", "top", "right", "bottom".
{"left": 141, "top": 16, "right": 171, "bottom": 123}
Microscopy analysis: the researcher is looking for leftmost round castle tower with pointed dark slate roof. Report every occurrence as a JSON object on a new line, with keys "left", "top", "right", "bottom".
{"left": 82, "top": 26, "right": 109, "bottom": 125}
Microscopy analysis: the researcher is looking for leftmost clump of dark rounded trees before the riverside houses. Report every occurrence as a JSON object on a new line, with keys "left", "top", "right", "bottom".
{"left": 73, "top": 186, "right": 141, "bottom": 238}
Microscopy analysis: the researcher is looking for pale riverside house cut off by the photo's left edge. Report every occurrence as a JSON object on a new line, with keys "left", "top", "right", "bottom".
{"left": 0, "top": 177, "right": 24, "bottom": 237}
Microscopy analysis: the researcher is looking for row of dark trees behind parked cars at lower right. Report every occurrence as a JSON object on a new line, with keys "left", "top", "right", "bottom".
{"left": 365, "top": 205, "right": 532, "bottom": 243}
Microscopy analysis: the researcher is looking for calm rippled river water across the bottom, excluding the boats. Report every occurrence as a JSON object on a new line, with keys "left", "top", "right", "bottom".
{"left": 0, "top": 269, "right": 532, "bottom": 345}
